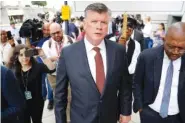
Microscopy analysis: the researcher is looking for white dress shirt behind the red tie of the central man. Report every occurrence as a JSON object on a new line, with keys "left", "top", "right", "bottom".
{"left": 84, "top": 38, "right": 107, "bottom": 82}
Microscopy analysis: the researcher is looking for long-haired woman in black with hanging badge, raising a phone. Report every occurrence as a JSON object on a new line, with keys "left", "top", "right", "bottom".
{"left": 8, "top": 45, "right": 55, "bottom": 123}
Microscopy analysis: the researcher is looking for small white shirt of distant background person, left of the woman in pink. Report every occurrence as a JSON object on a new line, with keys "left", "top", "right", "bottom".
{"left": 142, "top": 22, "right": 152, "bottom": 38}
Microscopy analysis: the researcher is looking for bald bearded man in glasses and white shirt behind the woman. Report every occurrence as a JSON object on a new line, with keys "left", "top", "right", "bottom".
{"left": 42, "top": 23, "right": 74, "bottom": 89}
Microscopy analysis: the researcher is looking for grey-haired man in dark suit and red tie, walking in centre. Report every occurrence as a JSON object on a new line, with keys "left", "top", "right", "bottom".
{"left": 55, "top": 3, "right": 132, "bottom": 123}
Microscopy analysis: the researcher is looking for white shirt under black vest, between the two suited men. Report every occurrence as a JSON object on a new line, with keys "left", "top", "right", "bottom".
{"left": 126, "top": 40, "right": 141, "bottom": 74}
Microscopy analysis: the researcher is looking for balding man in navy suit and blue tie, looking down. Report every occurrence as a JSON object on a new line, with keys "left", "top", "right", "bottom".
{"left": 134, "top": 22, "right": 185, "bottom": 123}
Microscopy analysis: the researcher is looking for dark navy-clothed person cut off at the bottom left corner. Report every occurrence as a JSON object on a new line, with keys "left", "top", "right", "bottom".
{"left": 1, "top": 66, "right": 25, "bottom": 123}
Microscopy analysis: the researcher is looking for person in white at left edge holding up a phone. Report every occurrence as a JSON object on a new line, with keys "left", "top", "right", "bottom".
{"left": 0, "top": 30, "right": 17, "bottom": 65}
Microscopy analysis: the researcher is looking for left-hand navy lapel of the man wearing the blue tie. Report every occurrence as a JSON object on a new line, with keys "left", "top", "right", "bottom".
{"left": 154, "top": 46, "right": 164, "bottom": 97}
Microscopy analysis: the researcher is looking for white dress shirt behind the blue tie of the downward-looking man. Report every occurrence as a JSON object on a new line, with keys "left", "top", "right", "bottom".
{"left": 149, "top": 52, "right": 181, "bottom": 115}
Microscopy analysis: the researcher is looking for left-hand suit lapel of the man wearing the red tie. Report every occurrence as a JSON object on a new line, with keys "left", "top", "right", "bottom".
{"left": 79, "top": 41, "right": 100, "bottom": 94}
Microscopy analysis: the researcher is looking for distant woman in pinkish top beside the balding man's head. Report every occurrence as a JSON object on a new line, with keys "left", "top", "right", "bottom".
{"left": 153, "top": 23, "right": 165, "bottom": 47}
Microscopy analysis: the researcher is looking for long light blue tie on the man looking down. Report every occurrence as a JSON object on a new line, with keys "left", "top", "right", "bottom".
{"left": 159, "top": 61, "right": 173, "bottom": 118}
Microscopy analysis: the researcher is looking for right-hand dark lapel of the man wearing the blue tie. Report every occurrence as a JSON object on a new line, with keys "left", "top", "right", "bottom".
{"left": 178, "top": 55, "right": 185, "bottom": 90}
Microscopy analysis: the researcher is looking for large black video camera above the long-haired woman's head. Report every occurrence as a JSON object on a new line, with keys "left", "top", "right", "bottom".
{"left": 19, "top": 19, "right": 43, "bottom": 42}
